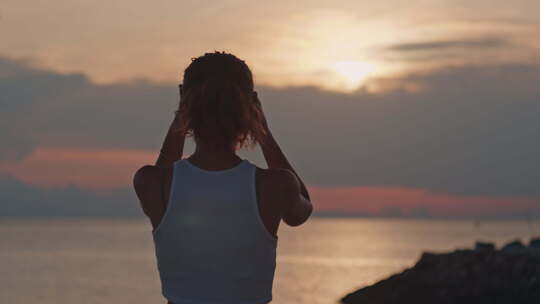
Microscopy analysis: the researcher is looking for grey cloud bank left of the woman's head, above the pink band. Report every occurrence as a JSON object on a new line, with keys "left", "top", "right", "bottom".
{"left": 0, "top": 58, "right": 178, "bottom": 159}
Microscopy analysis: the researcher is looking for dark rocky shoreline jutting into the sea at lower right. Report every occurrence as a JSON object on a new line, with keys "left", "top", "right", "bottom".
{"left": 341, "top": 238, "right": 540, "bottom": 304}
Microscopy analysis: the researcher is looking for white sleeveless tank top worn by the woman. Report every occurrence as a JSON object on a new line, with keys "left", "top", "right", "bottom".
{"left": 152, "top": 159, "right": 278, "bottom": 304}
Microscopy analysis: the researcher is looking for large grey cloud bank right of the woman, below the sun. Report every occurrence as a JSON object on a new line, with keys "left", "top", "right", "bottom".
{"left": 265, "top": 65, "right": 540, "bottom": 196}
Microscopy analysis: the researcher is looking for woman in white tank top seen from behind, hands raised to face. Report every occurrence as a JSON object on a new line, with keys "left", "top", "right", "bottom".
{"left": 133, "top": 52, "right": 313, "bottom": 304}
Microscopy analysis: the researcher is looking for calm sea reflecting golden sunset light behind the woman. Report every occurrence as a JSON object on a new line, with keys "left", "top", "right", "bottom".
{"left": 0, "top": 217, "right": 540, "bottom": 304}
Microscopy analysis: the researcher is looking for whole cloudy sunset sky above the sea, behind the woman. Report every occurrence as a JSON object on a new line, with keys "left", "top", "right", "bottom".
{"left": 0, "top": 0, "right": 540, "bottom": 218}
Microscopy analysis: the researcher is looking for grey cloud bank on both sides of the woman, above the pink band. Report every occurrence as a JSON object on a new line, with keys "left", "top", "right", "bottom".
{"left": 0, "top": 59, "right": 540, "bottom": 197}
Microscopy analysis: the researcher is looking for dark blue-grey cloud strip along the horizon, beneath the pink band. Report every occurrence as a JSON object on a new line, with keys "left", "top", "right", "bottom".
{"left": 0, "top": 175, "right": 540, "bottom": 220}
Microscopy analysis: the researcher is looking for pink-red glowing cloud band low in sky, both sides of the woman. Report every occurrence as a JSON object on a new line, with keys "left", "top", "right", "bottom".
{"left": 0, "top": 147, "right": 540, "bottom": 216}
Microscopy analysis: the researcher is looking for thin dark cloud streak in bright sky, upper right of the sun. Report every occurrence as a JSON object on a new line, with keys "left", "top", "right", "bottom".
{"left": 387, "top": 38, "right": 510, "bottom": 52}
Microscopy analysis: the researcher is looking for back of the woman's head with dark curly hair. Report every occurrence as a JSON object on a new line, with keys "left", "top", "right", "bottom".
{"left": 179, "top": 51, "right": 265, "bottom": 150}
